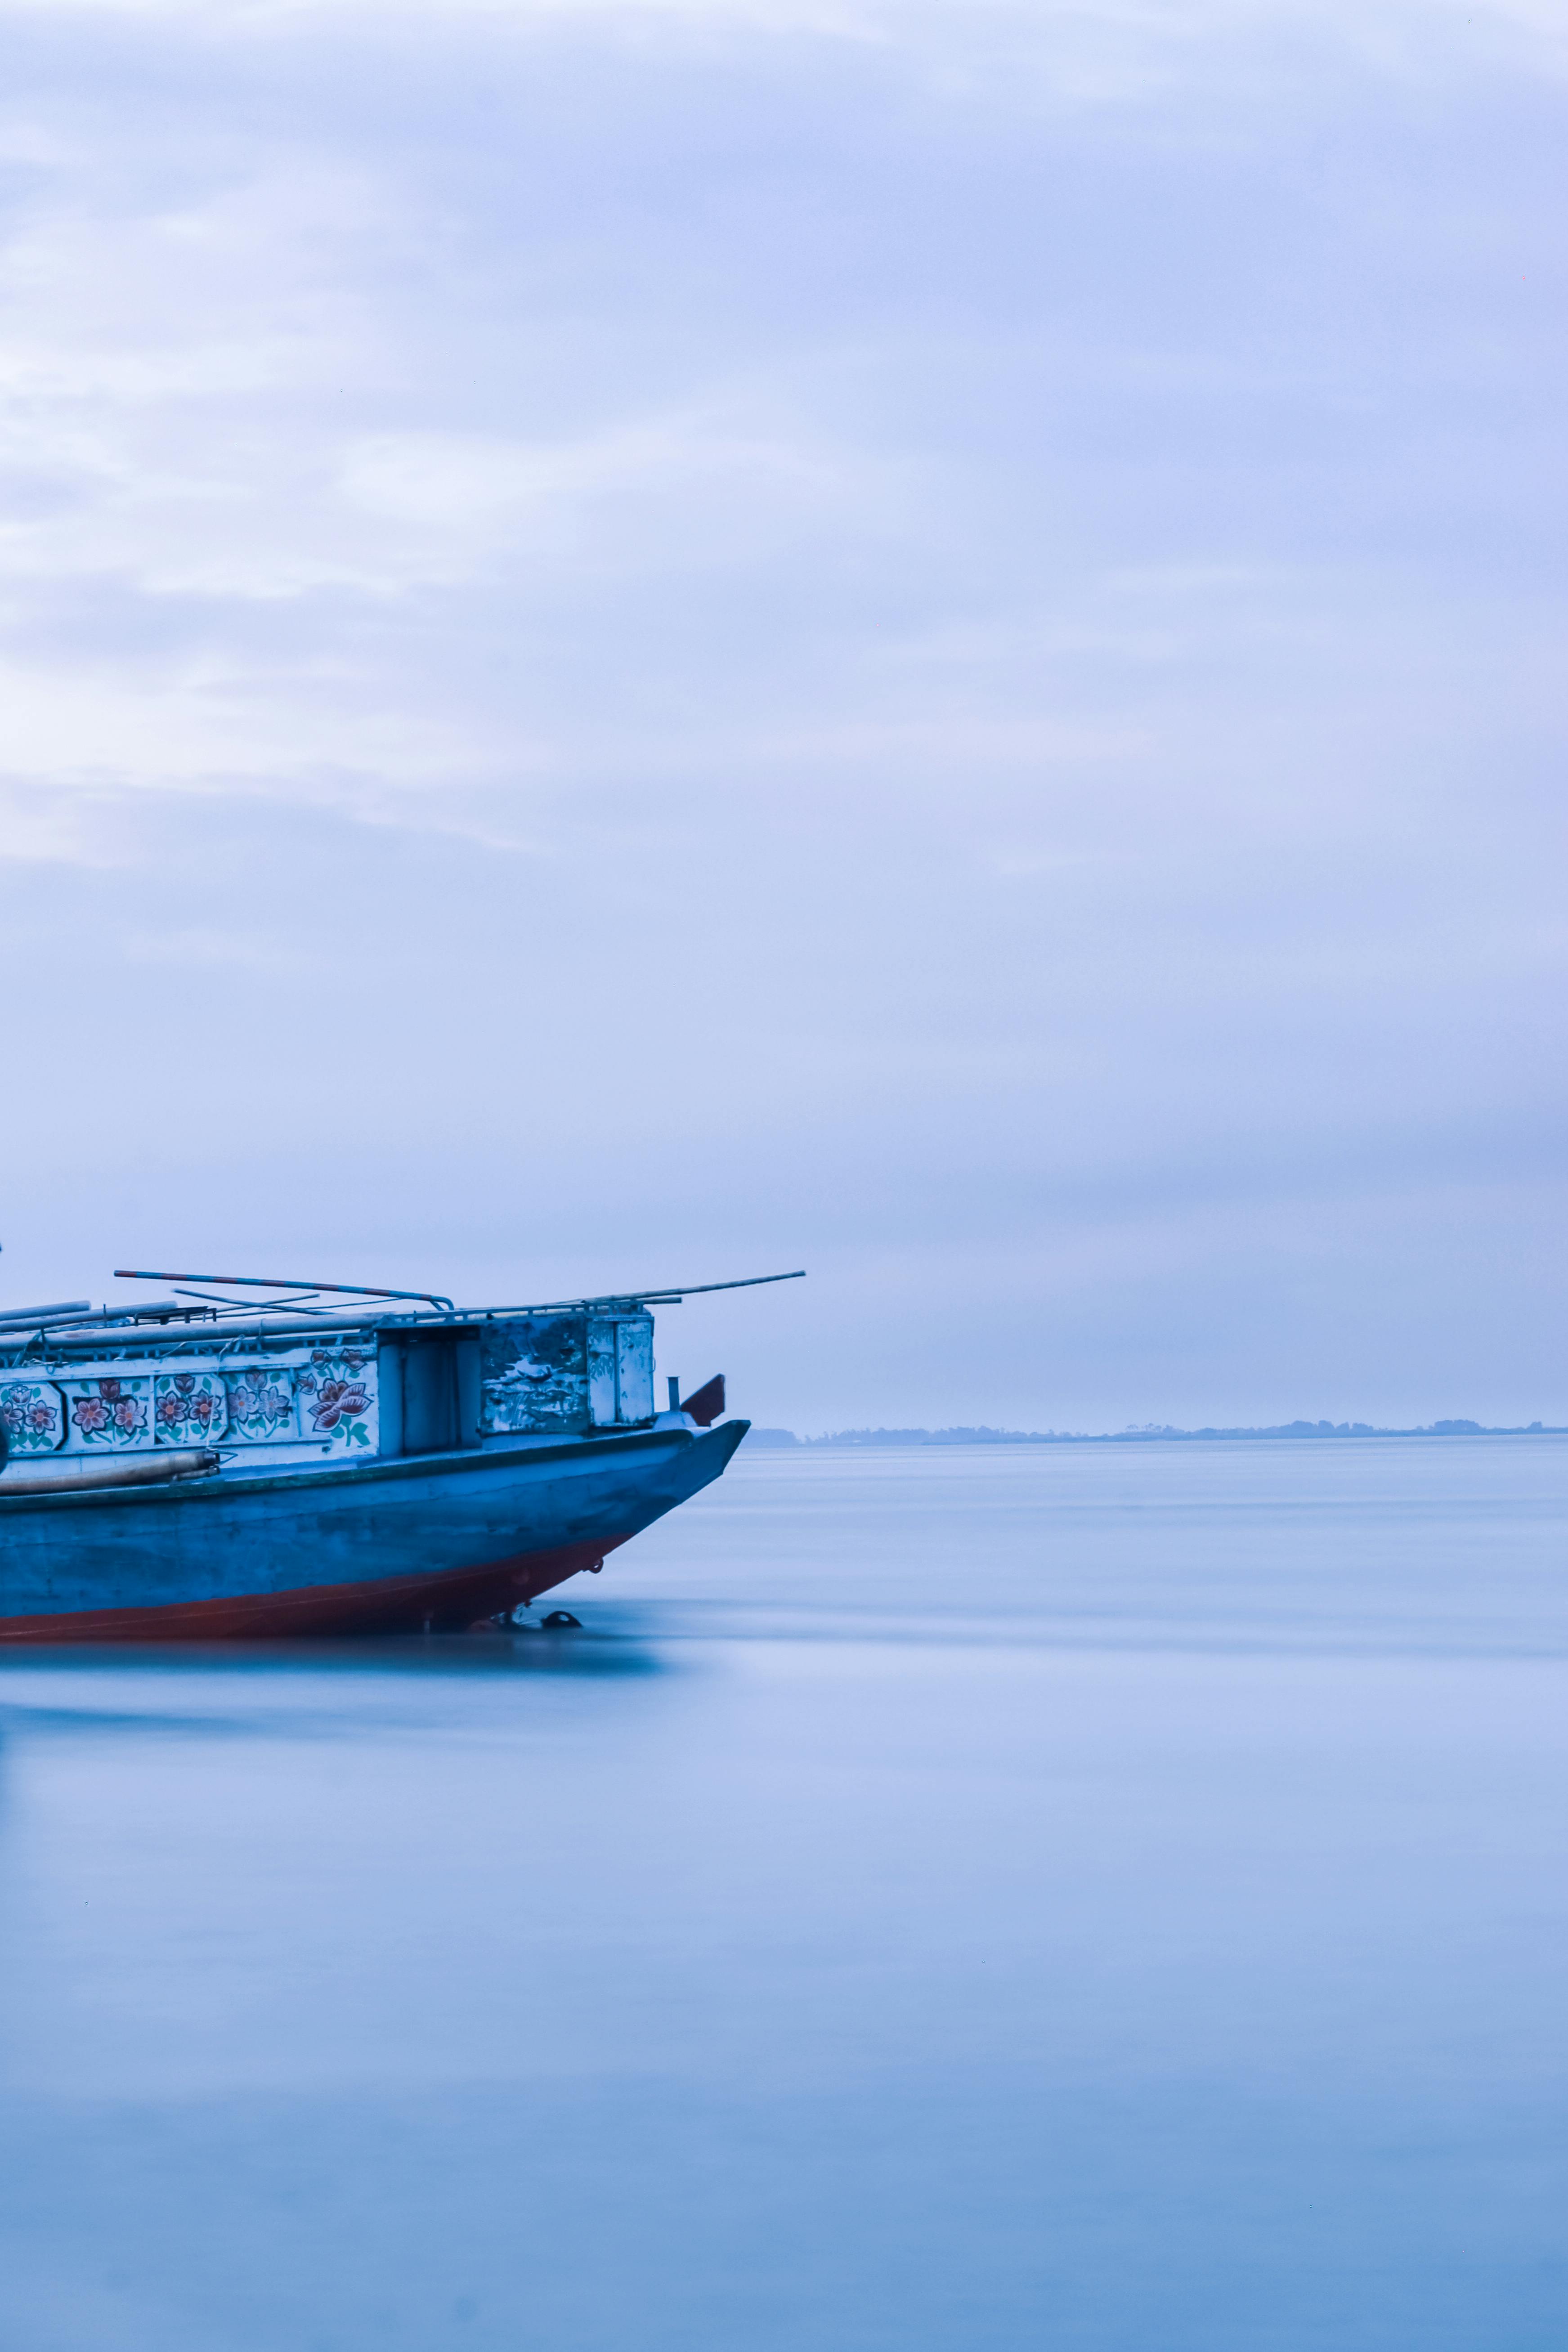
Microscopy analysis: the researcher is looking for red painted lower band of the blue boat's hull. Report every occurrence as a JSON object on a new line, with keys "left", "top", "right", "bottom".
{"left": 0, "top": 1536, "right": 627, "bottom": 1644}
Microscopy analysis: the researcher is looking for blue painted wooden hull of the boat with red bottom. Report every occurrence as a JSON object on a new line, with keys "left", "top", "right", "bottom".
{"left": 0, "top": 1420, "right": 748, "bottom": 1642}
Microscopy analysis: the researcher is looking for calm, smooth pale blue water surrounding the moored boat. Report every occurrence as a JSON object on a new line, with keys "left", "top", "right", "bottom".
{"left": 0, "top": 1439, "right": 1568, "bottom": 2352}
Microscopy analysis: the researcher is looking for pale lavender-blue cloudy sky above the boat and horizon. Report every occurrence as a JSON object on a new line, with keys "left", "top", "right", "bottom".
{"left": 0, "top": 0, "right": 1568, "bottom": 1430}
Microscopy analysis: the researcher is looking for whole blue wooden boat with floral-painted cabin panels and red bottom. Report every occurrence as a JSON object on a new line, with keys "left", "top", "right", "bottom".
{"left": 0, "top": 1275, "right": 792, "bottom": 1642}
